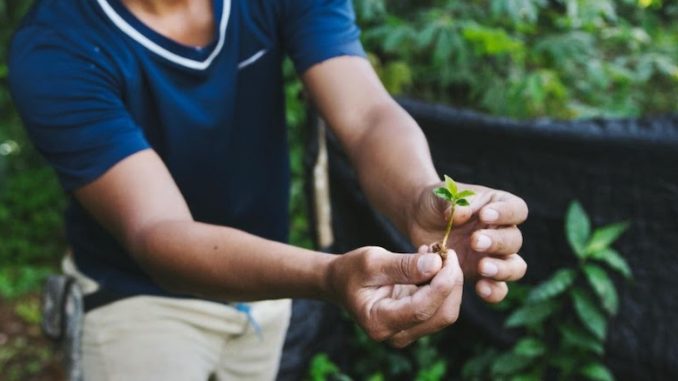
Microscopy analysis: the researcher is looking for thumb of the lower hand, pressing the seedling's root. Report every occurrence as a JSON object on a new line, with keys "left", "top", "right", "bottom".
{"left": 383, "top": 253, "right": 443, "bottom": 284}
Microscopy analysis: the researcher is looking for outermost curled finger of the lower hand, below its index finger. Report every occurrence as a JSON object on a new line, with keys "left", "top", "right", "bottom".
{"left": 388, "top": 255, "right": 464, "bottom": 348}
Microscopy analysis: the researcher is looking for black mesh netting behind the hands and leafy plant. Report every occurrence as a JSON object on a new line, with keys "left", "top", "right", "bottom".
{"left": 278, "top": 100, "right": 678, "bottom": 380}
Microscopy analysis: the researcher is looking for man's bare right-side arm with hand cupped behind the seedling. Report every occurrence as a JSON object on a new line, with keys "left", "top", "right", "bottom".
{"left": 302, "top": 57, "right": 527, "bottom": 302}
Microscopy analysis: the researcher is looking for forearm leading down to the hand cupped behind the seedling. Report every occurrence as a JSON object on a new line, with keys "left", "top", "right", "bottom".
{"left": 347, "top": 101, "right": 439, "bottom": 234}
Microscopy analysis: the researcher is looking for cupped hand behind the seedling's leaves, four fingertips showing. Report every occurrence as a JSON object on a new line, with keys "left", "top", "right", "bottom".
{"left": 409, "top": 184, "right": 528, "bottom": 303}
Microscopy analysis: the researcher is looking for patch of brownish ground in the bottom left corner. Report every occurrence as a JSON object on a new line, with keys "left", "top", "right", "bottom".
{"left": 0, "top": 294, "right": 64, "bottom": 381}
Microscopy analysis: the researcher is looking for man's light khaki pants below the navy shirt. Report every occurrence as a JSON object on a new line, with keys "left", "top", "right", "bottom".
{"left": 64, "top": 258, "right": 291, "bottom": 381}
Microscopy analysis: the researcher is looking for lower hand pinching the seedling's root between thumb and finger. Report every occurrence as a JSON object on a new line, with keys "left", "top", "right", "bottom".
{"left": 328, "top": 247, "right": 464, "bottom": 348}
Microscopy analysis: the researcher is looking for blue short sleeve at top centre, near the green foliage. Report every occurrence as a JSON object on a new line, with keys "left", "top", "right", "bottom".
{"left": 280, "top": 0, "right": 365, "bottom": 73}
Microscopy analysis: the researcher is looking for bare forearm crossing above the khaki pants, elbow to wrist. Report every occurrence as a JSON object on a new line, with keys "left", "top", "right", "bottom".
{"left": 130, "top": 221, "right": 335, "bottom": 301}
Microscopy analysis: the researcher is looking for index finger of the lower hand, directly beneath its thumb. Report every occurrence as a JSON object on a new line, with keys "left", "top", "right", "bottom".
{"left": 370, "top": 252, "right": 463, "bottom": 338}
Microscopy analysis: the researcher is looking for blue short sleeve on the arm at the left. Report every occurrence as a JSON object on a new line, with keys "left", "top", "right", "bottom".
{"left": 9, "top": 28, "right": 149, "bottom": 191}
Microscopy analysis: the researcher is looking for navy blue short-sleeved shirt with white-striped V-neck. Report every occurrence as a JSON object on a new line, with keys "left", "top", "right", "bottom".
{"left": 10, "top": 0, "right": 364, "bottom": 295}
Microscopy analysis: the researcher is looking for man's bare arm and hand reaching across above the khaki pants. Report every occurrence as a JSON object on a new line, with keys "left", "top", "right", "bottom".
{"left": 70, "top": 150, "right": 463, "bottom": 347}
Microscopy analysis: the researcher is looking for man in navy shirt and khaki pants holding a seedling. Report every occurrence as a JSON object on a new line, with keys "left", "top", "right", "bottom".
{"left": 10, "top": 0, "right": 527, "bottom": 380}
